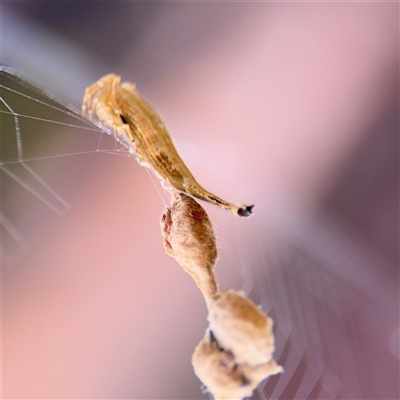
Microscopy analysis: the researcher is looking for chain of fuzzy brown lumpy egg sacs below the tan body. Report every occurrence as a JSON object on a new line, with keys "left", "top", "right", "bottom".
{"left": 160, "top": 192, "right": 283, "bottom": 399}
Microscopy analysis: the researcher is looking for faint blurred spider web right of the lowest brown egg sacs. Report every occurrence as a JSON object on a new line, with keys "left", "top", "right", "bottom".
{"left": 221, "top": 206, "right": 399, "bottom": 399}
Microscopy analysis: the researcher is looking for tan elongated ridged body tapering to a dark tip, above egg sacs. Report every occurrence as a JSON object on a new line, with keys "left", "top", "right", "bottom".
{"left": 82, "top": 74, "right": 253, "bottom": 217}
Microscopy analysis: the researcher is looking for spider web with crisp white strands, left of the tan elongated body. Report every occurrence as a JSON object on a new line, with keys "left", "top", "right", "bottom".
{"left": 0, "top": 67, "right": 128, "bottom": 264}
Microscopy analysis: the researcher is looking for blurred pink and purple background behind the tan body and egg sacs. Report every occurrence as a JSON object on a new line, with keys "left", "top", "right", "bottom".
{"left": 0, "top": 1, "right": 399, "bottom": 399}
